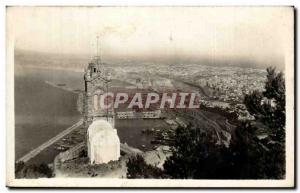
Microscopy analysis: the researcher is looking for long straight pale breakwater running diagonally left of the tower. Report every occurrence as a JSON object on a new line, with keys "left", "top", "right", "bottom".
{"left": 17, "top": 119, "right": 83, "bottom": 163}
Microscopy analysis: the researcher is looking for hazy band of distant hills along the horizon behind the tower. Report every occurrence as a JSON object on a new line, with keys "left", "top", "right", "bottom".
{"left": 15, "top": 49, "right": 284, "bottom": 70}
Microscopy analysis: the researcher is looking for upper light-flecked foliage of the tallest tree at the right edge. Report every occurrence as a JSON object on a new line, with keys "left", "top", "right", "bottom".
{"left": 244, "top": 67, "right": 285, "bottom": 143}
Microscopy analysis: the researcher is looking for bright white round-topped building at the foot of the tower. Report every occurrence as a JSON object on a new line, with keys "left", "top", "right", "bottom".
{"left": 87, "top": 120, "right": 120, "bottom": 164}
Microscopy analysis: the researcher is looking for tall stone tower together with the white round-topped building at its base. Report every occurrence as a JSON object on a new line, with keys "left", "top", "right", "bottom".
{"left": 84, "top": 37, "right": 120, "bottom": 164}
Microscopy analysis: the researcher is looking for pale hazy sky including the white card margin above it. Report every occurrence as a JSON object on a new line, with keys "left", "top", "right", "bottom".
{"left": 7, "top": 7, "right": 292, "bottom": 68}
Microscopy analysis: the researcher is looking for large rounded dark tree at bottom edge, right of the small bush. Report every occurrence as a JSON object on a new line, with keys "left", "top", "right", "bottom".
{"left": 164, "top": 125, "right": 233, "bottom": 179}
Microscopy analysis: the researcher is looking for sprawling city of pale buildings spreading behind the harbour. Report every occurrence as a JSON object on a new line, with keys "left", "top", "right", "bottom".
{"left": 105, "top": 63, "right": 266, "bottom": 119}
